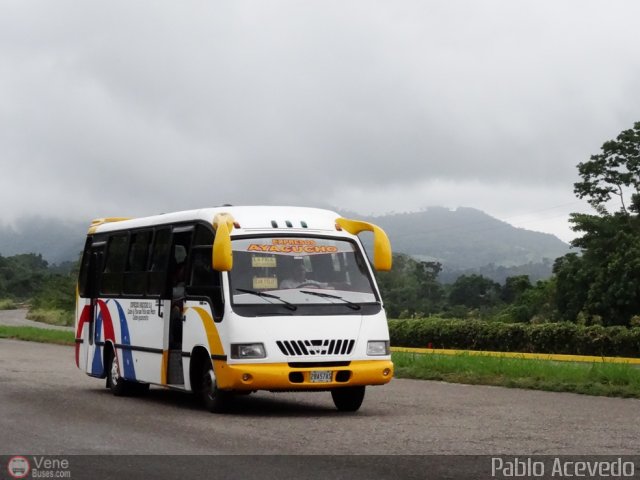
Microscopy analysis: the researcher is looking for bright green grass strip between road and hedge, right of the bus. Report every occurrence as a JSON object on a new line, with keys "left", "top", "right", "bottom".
{"left": 393, "top": 352, "right": 640, "bottom": 398}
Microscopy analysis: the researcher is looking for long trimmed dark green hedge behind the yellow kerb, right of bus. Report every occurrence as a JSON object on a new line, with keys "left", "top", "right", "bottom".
{"left": 389, "top": 318, "right": 640, "bottom": 357}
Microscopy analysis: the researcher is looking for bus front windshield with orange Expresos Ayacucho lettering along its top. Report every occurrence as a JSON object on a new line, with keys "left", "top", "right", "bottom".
{"left": 229, "top": 237, "right": 378, "bottom": 309}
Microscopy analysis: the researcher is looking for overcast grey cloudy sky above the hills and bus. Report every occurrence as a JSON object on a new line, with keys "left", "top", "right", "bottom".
{"left": 0, "top": 0, "right": 640, "bottom": 240}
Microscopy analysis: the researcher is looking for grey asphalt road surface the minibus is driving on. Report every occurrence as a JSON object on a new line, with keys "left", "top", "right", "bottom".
{"left": 0, "top": 314, "right": 640, "bottom": 479}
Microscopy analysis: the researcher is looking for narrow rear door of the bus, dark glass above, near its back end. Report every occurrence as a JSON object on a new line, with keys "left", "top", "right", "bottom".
{"left": 79, "top": 241, "right": 107, "bottom": 376}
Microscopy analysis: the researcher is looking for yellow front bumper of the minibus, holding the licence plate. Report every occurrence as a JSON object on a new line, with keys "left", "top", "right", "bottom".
{"left": 214, "top": 360, "right": 393, "bottom": 391}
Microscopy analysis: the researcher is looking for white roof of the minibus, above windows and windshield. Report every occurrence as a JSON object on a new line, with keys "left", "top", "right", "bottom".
{"left": 89, "top": 206, "right": 340, "bottom": 234}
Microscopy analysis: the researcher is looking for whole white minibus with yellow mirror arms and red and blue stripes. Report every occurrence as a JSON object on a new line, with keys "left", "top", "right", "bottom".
{"left": 75, "top": 206, "right": 393, "bottom": 412}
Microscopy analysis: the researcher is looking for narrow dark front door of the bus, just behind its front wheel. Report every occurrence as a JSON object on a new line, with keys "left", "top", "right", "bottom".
{"left": 164, "top": 227, "right": 193, "bottom": 385}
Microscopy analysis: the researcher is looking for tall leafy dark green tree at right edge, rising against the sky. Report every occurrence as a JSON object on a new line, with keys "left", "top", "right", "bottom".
{"left": 554, "top": 122, "right": 640, "bottom": 325}
